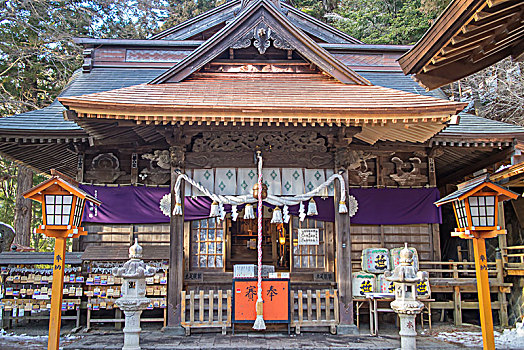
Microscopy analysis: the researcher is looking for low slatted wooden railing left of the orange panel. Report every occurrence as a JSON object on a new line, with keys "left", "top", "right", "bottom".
{"left": 181, "top": 290, "right": 231, "bottom": 335}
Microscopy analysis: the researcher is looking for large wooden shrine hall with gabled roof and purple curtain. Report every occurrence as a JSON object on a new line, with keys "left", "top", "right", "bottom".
{"left": 0, "top": 0, "right": 524, "bottom": 333}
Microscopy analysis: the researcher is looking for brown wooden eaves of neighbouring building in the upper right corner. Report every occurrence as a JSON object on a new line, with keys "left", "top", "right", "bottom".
{"left": 399, "top": 0, "right": 524, "bottom": 89}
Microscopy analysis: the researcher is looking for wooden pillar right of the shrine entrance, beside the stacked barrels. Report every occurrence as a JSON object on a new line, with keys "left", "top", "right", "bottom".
{"left": 335, "top": 147, "right": 358, "bottom": 334}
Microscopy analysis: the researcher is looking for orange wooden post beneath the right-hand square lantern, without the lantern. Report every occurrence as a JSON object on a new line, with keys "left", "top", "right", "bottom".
{"left": 473, "top": 237, "right": 495, "bottom": 350}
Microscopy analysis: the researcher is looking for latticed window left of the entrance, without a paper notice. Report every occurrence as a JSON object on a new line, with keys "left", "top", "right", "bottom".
{"left": 191, "top": 218, "right": 224, "bottom": 269}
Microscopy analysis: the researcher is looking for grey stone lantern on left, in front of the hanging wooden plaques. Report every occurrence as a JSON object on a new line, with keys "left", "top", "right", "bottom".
{"left": 113, "top": 239, "right": 156, "bottom": 350}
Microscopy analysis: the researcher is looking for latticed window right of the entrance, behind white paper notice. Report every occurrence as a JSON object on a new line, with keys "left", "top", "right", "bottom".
{"left": 292, "top": 217, "right": 326, "bottom": 269}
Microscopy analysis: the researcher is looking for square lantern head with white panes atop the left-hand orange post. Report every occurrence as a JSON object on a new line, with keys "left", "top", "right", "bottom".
{"left": 24, "top": 171, "right": 101, "bottom": 238}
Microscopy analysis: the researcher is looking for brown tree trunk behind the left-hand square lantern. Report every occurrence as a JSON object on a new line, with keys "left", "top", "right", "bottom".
{"left": 14, "top": 166, "right": 33, "bottom": 246}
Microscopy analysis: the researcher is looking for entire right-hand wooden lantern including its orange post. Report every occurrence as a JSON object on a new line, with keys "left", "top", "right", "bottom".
{"left": 435, "top": 175, "right": 518, "bottom": 350}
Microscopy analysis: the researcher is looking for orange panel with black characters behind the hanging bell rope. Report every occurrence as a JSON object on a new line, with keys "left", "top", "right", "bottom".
{"left": 233, "top": 278, "right": 291, "bottom": 323}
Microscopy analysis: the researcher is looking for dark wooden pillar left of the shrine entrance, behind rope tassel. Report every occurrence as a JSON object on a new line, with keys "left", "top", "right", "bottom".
{"left": 166, "top": 146, "right": 185, "bottom": 334}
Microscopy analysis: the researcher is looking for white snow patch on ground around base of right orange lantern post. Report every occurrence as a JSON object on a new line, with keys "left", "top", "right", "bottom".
{"left": 437, "top": 328, "right": 524, "bottom": 350}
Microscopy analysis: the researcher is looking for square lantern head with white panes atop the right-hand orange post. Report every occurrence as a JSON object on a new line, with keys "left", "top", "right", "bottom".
{"left": 435, "top": 175, "right": 518, "bottom": 238}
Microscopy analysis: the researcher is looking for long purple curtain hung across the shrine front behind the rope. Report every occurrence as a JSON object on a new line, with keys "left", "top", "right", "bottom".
{"left": 81, "top": 185, "right": 441, "bottom": 225}
